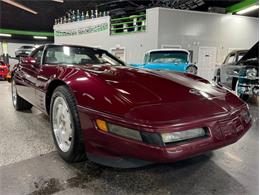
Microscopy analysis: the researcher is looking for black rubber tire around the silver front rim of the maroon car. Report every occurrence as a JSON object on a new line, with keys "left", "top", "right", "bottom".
{"left": 50, "top": 85, "right": 87, "bottom": 162}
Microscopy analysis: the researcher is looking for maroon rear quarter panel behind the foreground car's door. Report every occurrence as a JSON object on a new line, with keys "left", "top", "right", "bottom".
{"left": 16, "top": 46, "right": 43, "bottom": 105}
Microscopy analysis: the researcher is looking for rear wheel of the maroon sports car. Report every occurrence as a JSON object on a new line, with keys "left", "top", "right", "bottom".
{"left": 11, "top": 80, "right": 32, "bottom": 111}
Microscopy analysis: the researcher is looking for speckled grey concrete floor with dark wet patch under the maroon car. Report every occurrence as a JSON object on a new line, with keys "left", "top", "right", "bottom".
{"left": 0, "top": 81, "right": 259, "bottom": 195}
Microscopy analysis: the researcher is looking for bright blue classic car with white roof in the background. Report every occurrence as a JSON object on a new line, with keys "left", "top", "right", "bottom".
{"left": 131, "top": 49, "right": 198, "bottom": 74}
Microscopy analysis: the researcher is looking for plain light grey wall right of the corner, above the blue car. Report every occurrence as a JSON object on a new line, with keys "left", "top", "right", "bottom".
{"left": 158, "top": 8, "right": 259, "bottom": 63}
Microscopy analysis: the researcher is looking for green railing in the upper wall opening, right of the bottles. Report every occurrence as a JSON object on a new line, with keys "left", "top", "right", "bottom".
{"left": 110, "top": 13, "right": 146, "bottom": 35}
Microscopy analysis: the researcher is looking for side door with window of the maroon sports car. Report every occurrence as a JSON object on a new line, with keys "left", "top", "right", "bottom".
{"left": 35, "top": 45, "right": 60, "bottom": 111}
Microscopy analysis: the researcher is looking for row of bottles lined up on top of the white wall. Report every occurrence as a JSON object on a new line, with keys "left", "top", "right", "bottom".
{"left": 54, "top": 10, "right": 109, "bottom": 25}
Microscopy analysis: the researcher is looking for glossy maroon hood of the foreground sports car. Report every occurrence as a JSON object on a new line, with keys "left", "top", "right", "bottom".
{"left": 78, "top": 65, "right": 243, "bottom": 122}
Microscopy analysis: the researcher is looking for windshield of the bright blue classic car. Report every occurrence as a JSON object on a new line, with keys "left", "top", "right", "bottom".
{"left": 149, "top": 51, "right": 188, "bottom": 64}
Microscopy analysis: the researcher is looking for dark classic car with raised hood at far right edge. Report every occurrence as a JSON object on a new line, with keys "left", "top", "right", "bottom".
{"left": 213, "top": 43, "right": 259, "bottom": 100}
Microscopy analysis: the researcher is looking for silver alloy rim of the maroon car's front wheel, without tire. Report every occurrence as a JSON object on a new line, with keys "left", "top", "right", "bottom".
{"left": 52, "top": 96, "right": 73, "bottom": 152}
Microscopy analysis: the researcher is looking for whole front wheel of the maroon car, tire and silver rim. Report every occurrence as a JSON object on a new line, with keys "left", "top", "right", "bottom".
{"left": 50, "top": 86, "right": 86, "bottom": 162}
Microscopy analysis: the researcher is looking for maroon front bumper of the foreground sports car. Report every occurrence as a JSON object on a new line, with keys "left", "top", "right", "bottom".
{"left": 79, "top": 105, "right": 252, "bottom": 168}
